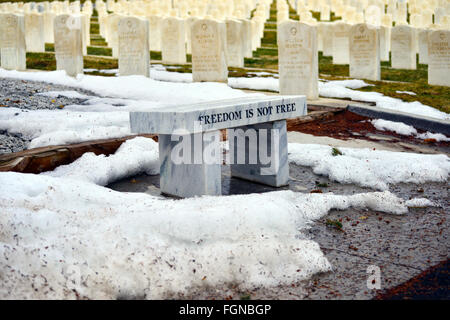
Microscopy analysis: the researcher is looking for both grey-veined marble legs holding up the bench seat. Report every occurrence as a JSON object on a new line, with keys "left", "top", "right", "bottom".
{"left": 158, "top": 120, "right": 289, "bottom": 198}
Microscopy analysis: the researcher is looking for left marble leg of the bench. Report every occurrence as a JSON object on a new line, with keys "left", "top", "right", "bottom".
{"left": 158, "top": 133, "right": 222, "bottom": 198}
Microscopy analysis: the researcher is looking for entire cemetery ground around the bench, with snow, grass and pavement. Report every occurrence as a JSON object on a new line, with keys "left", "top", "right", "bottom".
{"left": 0, "top": 4, "right": 450, "bottom": 299}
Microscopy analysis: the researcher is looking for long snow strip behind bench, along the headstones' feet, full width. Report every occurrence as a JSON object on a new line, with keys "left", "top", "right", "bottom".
{"left": 0, "top": 66, "right": 450, "bottom": 120}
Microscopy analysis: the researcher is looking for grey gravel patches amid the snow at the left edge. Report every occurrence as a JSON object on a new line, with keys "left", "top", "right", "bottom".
{"left": 0, "top": 78, "right": 95, "bottom": 154}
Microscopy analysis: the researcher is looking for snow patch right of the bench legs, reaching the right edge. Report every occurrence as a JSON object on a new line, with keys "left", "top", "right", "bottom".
{"left": 288, "top": 143, "right": 450, "bottom": 190}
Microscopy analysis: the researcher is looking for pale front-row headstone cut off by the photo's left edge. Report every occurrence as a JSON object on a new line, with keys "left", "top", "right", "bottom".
{"left": 0, "top": 14, "right": 26, "bottom": 70}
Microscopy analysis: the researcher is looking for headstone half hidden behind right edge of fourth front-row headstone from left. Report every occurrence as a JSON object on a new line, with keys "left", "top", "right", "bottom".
{"left": 226, "top": 20, "right": 244, "bottom": 68}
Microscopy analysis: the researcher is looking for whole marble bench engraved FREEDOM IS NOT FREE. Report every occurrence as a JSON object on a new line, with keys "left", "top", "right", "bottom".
{"left": 130, "top": 96, "right": 307, "bottom": 197}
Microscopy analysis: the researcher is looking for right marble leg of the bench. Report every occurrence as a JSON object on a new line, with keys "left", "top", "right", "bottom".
{"left": 227, "top": 120, "right": 289, "bottom": 187}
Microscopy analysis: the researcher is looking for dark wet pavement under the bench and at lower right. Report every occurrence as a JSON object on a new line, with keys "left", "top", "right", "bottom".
{"left": 108, "top": 164, "right": 450, "bottom": 299}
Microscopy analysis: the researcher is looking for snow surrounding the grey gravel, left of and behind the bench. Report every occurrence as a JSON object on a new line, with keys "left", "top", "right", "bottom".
{"left": 0, "top": 69, "right": 255, "bottom": 148}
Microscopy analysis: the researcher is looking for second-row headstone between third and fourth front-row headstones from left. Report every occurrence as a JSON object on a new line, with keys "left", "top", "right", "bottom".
{"left": 161, "top": 17, "right": 186, "bottom": 64}
